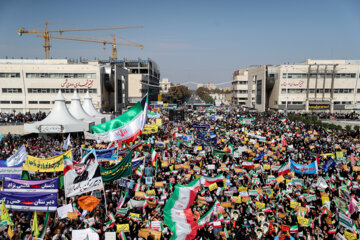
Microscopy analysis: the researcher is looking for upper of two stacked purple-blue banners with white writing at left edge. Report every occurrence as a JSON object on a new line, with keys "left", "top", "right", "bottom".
{"left": 4, "top": 178, "right": 58, "bottom": 193}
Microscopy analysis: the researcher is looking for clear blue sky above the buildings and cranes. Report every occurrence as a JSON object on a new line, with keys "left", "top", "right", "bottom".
{"left": 0, "top": 0, "right": 360, "bottom": 88}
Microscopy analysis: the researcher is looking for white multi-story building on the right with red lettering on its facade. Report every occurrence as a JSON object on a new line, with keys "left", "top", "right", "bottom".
{"left": 233, "top": 59, "right": 360, "bottom": 112}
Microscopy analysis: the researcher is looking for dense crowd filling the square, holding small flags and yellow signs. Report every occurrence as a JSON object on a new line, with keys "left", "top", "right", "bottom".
{"left": 0, "top": 108, "right": 360, "bottom": 240}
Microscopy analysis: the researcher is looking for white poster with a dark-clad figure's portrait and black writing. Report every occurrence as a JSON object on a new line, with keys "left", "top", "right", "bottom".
{"left": 64, "top": 151, "right": 104, "bottom": 197}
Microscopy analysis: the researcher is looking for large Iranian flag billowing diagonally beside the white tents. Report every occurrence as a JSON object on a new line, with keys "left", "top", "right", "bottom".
{"left": 91, "top": 94, "right": 148, "bottom": 142}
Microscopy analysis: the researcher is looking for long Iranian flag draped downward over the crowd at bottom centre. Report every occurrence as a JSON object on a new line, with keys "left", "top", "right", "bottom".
{"left": 163, "top": 179, "right": 200, "bottom": 239}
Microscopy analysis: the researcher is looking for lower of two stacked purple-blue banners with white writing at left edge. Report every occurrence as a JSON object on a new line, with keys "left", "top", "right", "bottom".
{"left": 0, "top": 191, "right": 57, "bottom": 212}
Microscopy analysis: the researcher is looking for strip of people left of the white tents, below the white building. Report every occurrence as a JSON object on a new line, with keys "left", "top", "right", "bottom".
{"left": 0, "top": 112, "right": 46, "bottom": 124}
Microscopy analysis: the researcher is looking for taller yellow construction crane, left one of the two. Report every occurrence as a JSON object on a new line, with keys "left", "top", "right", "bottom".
{"left": 18, "top": 21, "right": 143, "bottom": 59}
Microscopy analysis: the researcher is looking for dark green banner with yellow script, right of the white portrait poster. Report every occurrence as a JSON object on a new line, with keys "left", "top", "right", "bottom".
{"left": 100, "top": 152, "right": 132, "bottom": 182}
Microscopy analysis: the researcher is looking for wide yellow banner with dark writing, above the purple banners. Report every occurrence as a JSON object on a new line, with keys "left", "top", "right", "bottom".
{"left": 23, "top": 150, "right": 72, "bottom": 172}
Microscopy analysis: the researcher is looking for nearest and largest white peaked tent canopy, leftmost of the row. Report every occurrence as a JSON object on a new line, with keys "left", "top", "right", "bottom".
{"left": 24, "top": 91, "right": 90, "bottom": 133}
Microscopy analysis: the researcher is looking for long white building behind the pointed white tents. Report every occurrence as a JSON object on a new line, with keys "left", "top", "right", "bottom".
{"left": 0, "top": 59, "right": 127, "bottom": 113}
